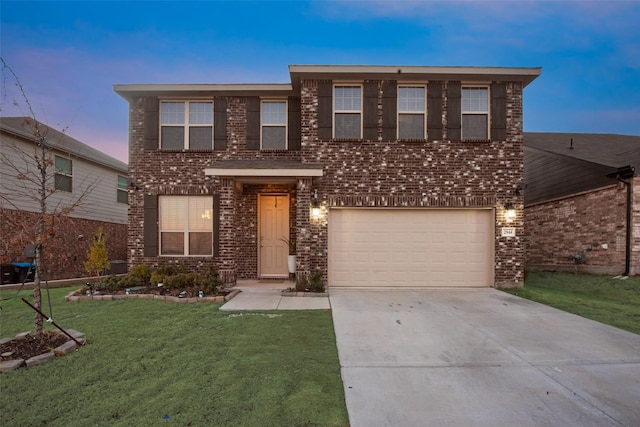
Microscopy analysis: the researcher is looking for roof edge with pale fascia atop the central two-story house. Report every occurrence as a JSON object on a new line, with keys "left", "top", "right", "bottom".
{"left": 113, "top": 65, "right": 542, "bottom": 99}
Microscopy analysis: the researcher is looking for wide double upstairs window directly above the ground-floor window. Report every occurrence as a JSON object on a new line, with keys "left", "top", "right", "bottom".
{"left": 160, "top": 101, "right": 213, "bottom": 150}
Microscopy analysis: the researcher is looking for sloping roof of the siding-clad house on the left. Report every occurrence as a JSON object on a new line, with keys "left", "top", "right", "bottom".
{"left": 0, "top": 117, "right": 128, "bottom": 174}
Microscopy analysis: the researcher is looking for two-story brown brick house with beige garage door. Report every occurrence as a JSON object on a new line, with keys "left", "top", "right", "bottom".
{"left": 114, "top": 65, "right": 540, "bottom": 287}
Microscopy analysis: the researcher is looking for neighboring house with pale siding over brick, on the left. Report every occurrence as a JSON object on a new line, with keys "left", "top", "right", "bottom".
{"left": 0, "top": 117, "right": 129, "bottom": 280}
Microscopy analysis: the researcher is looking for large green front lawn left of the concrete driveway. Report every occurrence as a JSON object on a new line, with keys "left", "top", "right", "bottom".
{"left": 0, "top": 288, "right": 348, "bottom": 426}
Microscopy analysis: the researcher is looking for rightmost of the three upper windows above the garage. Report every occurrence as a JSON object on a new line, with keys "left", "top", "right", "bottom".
{"left": 462, "top": 87, "right": 489, "bottom": 139}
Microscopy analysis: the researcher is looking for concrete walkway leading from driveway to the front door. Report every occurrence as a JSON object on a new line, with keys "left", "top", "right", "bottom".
{"left": 220, "top": 281, "right": 331, "bottom": 311}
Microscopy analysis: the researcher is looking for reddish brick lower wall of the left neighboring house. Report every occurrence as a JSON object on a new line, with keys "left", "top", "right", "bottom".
{"left": 0, "top": 209, "right": 127, "bottom": 280}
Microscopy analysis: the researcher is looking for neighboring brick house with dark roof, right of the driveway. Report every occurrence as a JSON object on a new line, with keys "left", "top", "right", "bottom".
{"left": 524, "top": 132, "right": 640, "bottom": 275}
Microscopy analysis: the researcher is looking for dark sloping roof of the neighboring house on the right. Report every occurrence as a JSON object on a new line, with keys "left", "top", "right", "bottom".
{"left": 524, "top": 132, "right": 640, "bottom": 205}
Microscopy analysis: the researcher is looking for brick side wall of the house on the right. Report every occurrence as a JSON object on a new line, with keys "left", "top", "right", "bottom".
{"left": 524, "top": 184, "right": 628, "bottom": 274}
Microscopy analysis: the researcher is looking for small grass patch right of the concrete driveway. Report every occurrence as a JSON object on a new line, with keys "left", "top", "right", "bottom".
{"left": 510, "top": 271, "right": 640, "bottom": 334}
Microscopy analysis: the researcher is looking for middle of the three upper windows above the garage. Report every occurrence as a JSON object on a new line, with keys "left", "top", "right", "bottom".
{"left": 398, "top": 86, "right": 426, "bottom": 139}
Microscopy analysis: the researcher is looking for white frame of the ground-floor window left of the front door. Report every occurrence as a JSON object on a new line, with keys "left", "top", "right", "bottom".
{"left": 158, "top": 195, "right": 215, "bottom": 258}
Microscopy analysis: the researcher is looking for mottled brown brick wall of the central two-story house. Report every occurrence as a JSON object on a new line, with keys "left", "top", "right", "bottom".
{"left": 128, "top": 80, "right": 524, "bottom": 287}
